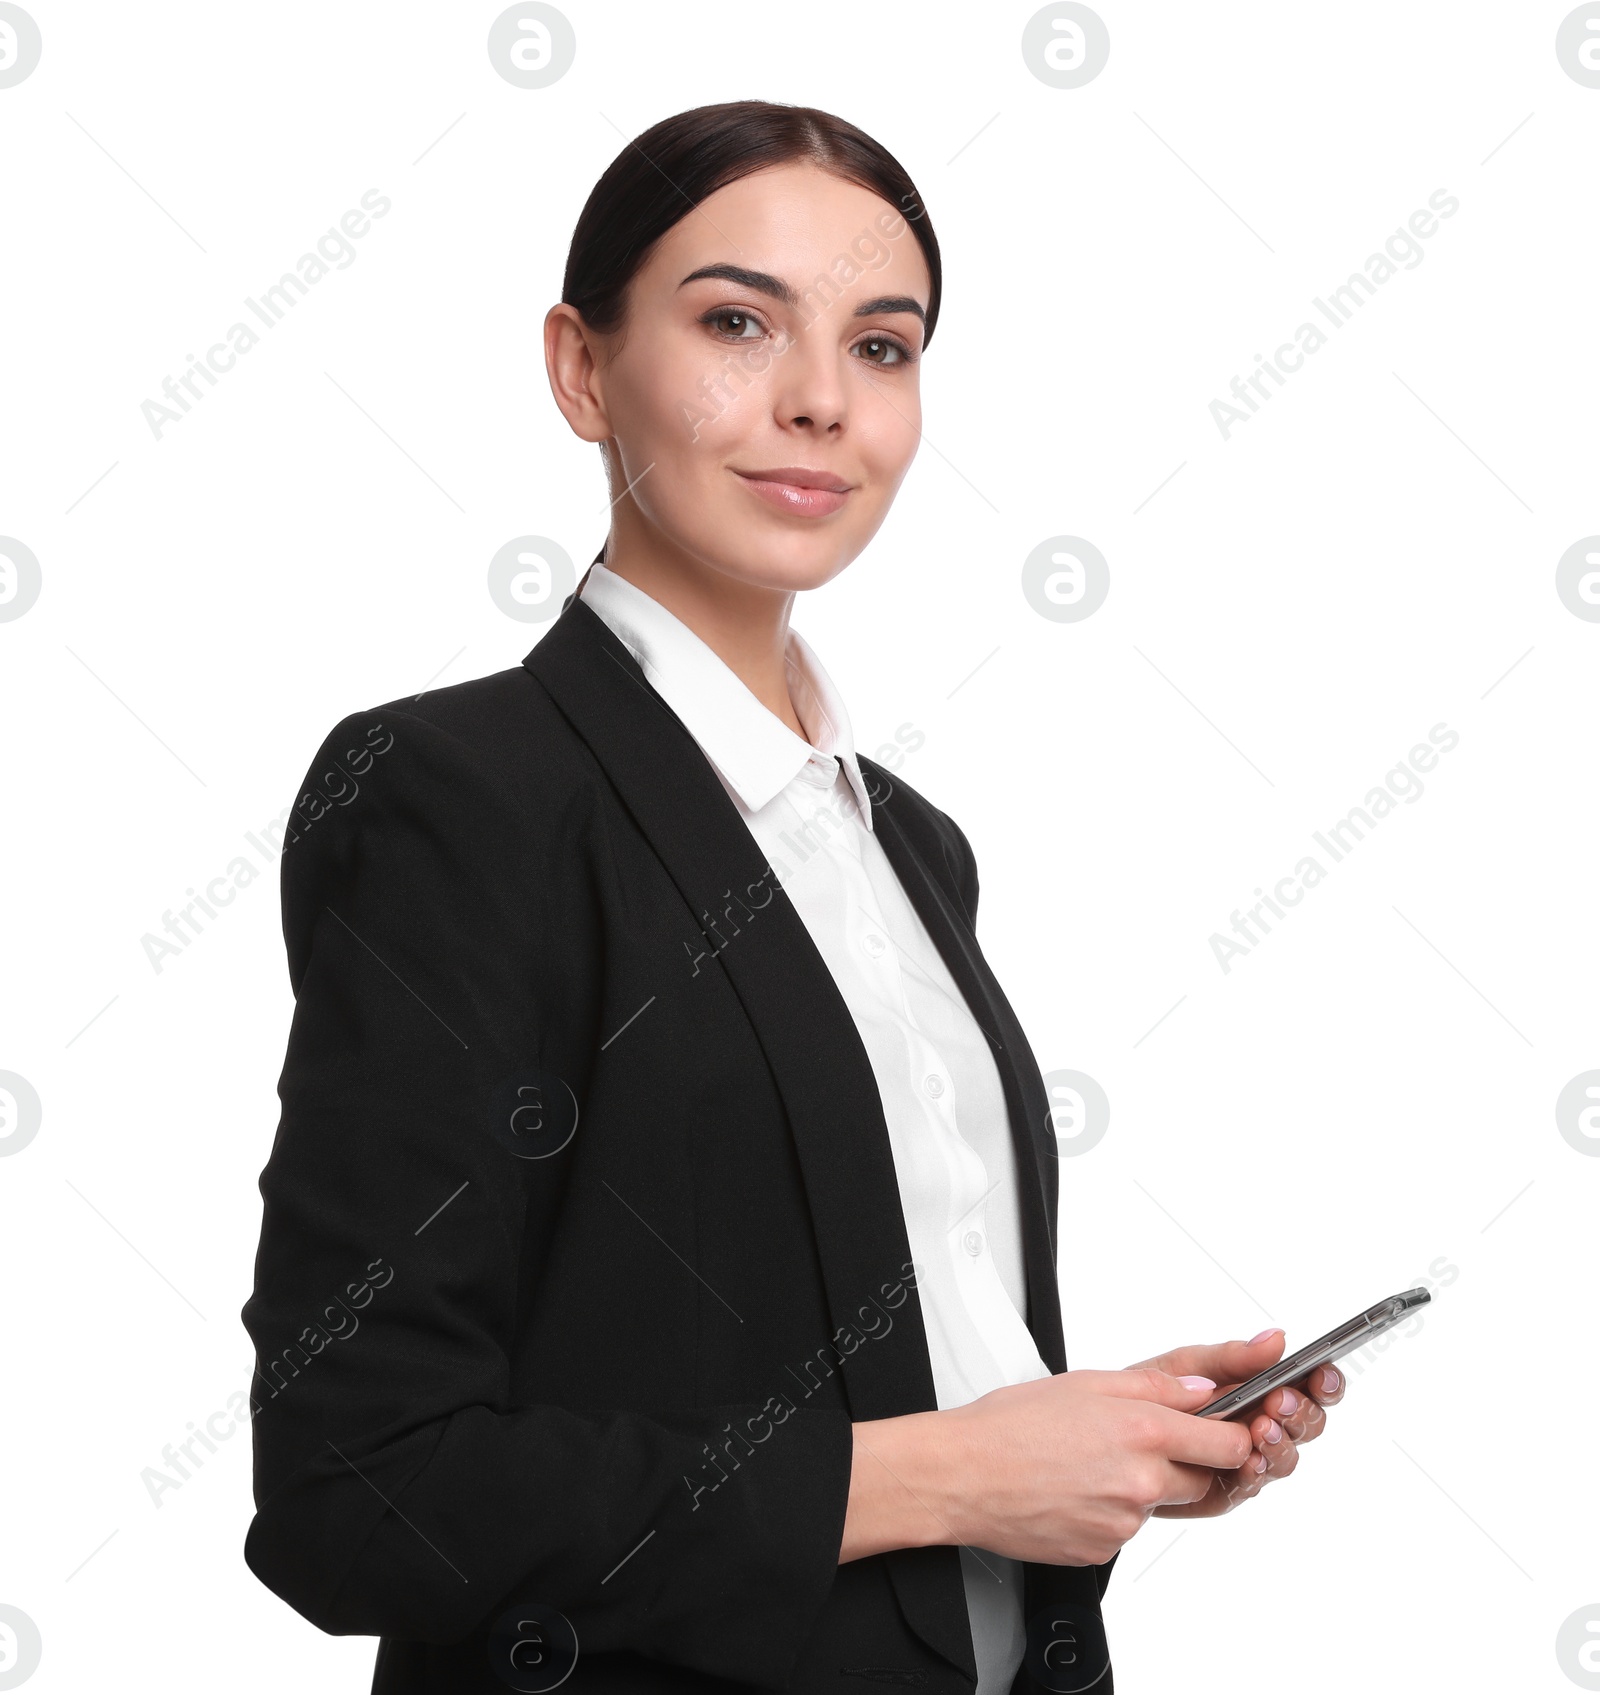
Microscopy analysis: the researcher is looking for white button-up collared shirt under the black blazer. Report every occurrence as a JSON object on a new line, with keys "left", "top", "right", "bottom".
{"left": 583, "top": 564, "right": 1049, "bottom": 1695}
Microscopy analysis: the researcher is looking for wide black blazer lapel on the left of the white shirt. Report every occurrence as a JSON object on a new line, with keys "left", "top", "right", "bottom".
{"left": 524, "top": 600, "right": 983, "bottom": 1678}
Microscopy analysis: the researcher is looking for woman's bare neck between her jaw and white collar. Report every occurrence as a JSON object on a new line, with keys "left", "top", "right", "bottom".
{"left": 605, "top": 512, "right": 805, "bottom": 737}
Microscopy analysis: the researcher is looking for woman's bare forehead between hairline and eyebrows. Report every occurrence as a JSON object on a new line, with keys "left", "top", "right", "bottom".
{"left": 644, "top": 164, "right": 929, "bottom": 305}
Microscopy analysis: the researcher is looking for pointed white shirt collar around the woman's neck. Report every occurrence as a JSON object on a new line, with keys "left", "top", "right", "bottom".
{"left": 581, "top": 563, "right": 873, "bottom": 829}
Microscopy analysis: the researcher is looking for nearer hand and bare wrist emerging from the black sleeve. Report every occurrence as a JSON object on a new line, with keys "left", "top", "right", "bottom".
{"left": 839, "top": 1368, "right": 1253, "bottom": 1566}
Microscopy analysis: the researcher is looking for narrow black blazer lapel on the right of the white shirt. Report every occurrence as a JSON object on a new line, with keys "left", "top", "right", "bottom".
{"left": 861, "top": 759, "right": 1066, "bottom": 1371}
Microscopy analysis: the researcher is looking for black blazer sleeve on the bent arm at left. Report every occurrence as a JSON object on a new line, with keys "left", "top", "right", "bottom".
{"left": 242, "top": 709, "right": 851, "bottom": 1688}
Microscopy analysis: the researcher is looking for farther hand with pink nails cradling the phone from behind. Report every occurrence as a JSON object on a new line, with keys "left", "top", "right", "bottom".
{"left": 1129, "top": 1331, "right": 1346, "bottom": 1519}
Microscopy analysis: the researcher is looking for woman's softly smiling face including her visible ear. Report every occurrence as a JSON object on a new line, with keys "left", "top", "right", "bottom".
{"left": 546, "top": 164, "right": 929, "bottom": 592}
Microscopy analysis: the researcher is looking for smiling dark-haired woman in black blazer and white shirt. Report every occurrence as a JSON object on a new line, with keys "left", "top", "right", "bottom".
{"left": 244, "top": 102, "right": 1342, "bottom": 1695}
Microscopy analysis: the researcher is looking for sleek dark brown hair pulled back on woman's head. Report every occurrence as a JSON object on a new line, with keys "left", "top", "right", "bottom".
{"left": 561, "top": 100, "right": 941, "bottom": 347}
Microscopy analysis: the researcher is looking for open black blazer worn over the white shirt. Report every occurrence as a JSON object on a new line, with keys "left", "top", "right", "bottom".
{"left": 244, "top": 600, "right": 1112, "bottom": 1695}
